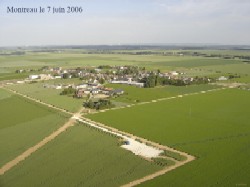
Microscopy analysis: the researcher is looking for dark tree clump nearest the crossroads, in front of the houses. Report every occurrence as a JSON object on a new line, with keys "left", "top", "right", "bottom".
{"left": 83, "top": 99, "right": 114, "bottom": 110}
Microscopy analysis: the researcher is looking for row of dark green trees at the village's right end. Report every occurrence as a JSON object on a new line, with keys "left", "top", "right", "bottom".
{"left": 141, "top": 74, "right": 215, "bottom": 88}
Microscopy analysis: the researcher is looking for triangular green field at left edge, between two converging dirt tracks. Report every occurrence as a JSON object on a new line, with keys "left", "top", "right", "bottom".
{"left": 0, "top": 89, "right": 67, "bottom": 166}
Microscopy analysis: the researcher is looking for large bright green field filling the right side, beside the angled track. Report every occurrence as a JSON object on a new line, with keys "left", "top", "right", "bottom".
{"left": 88, "top": 89, "right": 250, "bottom": 186}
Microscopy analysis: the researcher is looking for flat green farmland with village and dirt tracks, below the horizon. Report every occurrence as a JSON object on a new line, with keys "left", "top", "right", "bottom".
{"left": 0, "top": 44, "right": 250, "bottom": 187}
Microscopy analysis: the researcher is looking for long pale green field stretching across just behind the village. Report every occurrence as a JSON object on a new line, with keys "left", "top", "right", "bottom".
{"left": 0, "top": 53, "right": 243, "bottom": 68}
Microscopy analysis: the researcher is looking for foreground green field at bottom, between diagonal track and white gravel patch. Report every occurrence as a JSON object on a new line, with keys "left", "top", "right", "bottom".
{"left": 1, "top": 124, "right": 161, "bottom": 187}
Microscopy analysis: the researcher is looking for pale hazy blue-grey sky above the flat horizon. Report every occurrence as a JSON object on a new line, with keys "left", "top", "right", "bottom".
{"left": 0, "top": 0, "right": 250, "bottom": 46}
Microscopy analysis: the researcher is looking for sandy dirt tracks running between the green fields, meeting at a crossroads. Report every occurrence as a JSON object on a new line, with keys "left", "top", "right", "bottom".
{"left": 0, "top": 87, "right": 200, "bottom": 184}
